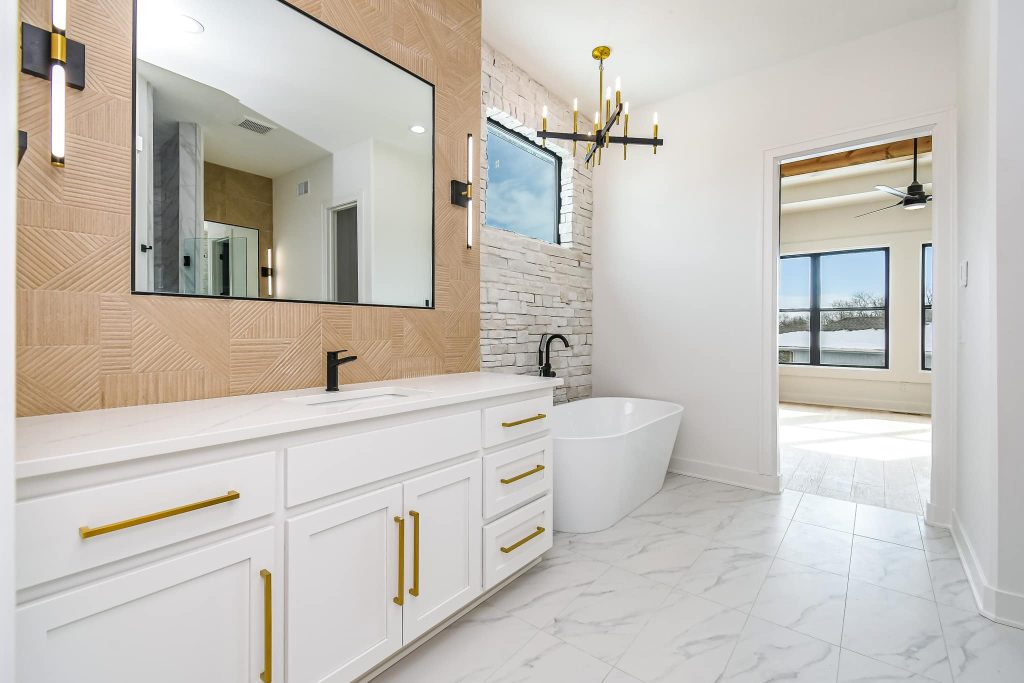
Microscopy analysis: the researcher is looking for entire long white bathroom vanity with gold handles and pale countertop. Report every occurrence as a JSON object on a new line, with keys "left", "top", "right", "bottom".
{"left": 16, "top": 373, "right": 560, "bottom": 683}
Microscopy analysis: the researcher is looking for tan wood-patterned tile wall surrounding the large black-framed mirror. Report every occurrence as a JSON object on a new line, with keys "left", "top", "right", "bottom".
{"left": 17, "top": 0, "right": 480, "bottom": 416}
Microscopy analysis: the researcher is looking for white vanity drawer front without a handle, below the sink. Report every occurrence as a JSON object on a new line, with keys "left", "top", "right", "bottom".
{"left": 285, "top": 411, "right": 480, "bottom": 507}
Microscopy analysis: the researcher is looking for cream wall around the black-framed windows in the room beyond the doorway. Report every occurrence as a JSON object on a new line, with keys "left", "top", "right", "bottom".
{"left": 778, "top": 163, "right": 932, "bottom": 415}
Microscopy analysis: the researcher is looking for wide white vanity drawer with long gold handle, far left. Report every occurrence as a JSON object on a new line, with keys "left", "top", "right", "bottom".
{"left": 15, "top": 453, "right": 275, "bottom": 589}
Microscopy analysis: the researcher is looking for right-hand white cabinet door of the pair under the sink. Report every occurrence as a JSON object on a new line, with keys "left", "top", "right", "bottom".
{"left": 402, "top": 460, "right": 482, "bottom": 643}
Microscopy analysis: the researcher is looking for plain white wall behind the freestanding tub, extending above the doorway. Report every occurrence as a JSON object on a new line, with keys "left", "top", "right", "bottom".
{"left": 594, "top": 12, "right": 955, "bottom": 486}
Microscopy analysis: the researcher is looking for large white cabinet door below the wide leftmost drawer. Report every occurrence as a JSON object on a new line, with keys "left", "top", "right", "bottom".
{"left": 17, "top": 528, "right": 281, "bottom": 683}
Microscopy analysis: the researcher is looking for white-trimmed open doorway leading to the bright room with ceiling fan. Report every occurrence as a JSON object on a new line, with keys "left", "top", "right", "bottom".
{"left": 761, "top": 113, "right": 956, "bottom": 525}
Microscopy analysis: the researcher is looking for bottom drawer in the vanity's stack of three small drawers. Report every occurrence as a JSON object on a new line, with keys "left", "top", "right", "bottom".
{"left": 483, "top": 496, "right": 554, "bottom": 591}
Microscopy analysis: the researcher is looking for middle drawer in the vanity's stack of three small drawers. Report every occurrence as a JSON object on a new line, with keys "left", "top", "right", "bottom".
{"left": 483, "top": 436, "right": 553, "bottom": 519}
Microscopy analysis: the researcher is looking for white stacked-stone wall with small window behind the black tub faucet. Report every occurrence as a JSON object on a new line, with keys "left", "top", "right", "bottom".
{"left": 476, "top": 43, "right": 594, "bottom": 401}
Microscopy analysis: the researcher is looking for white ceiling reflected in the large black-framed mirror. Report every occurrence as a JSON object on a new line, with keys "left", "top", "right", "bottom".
{"left": 136, "top": 0, "right": 433, "bottom": 179}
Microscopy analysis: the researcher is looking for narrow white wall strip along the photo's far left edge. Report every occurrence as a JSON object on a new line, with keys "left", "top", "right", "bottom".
{"left": 0, "top": 2, "right": 17, "bottom": 671}
